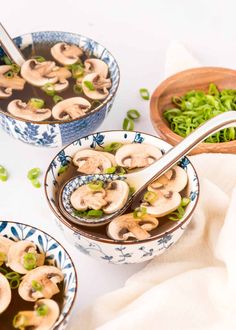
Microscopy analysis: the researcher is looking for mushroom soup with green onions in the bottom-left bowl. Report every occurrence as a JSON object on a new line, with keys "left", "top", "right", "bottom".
{"left": 0, "top": 235, "right": 64, "bottom": 330}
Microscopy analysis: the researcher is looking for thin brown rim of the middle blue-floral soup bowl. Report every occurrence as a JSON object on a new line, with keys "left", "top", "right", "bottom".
{"left": 44, "top": 130, "right": 200, "bottom": 245}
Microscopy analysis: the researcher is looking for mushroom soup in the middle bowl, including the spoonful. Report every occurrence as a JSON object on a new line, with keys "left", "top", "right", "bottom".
{"left": 55, "top": 142, "right": 189, "bottom": 241}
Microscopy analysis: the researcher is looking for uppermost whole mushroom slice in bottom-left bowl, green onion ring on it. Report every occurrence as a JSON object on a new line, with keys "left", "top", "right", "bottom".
{"left": 7, "top": 241, "right": 45, "bottom": 274}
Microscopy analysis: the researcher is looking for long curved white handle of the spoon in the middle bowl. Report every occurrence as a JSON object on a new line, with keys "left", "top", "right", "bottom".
{"left": 127, "top": 111, "right": 236, "bottom": 192}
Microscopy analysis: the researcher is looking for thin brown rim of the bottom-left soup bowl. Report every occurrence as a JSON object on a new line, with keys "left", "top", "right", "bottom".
{"left": 0, "top": 218, "right": 78, "bottom": 330}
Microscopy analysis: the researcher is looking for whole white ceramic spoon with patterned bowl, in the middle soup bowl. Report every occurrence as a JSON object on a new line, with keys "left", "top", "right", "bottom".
{"left": 59, "top": 111, "right": 236, "bottom": 226}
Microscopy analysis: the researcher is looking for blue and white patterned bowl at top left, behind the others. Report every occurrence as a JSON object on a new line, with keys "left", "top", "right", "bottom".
{"left": 0, "top": 31, "right": 120, "bottom": 147}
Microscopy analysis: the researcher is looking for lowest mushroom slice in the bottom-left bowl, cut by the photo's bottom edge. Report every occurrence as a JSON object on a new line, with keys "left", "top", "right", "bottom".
{"left": 14, "top": 299, "right": 60, "bottom": 330}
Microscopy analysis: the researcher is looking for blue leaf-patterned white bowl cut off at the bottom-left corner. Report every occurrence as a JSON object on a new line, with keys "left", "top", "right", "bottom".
{"left": 0, "top": 220, "right": 77, "bottom": 330}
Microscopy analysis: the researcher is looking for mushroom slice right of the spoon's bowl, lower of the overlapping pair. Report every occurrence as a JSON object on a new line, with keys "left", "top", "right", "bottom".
{"left": 141, "top": 191, "right": 181, "bottom": 217}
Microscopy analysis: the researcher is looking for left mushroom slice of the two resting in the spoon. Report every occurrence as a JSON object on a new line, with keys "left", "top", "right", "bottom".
{"left": 70, "top": 185, "right": 107, "bottom": 211}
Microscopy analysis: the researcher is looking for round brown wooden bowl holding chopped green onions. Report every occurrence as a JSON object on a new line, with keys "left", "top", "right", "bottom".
{"left": 150, "top": 67, "right": 236, "bottom": 155}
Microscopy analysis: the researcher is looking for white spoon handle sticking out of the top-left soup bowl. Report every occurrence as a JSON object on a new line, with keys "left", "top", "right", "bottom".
{"left": 0, "top": 23, "right": 25, "bottom": 66}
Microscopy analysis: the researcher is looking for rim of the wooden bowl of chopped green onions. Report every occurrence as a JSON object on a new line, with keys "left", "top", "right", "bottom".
{"left": 149, "top": 66, "right": 236, "bottom": 148}
